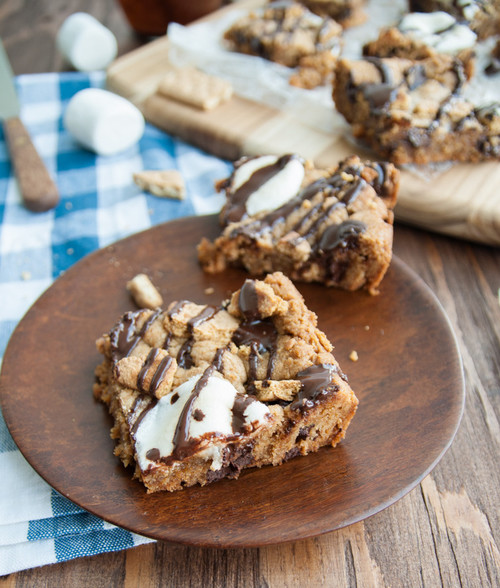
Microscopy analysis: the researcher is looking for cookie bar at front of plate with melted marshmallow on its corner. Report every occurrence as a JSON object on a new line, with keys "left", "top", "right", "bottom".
{"left": 94, "top": 273, "right": 358, "bottom": 492}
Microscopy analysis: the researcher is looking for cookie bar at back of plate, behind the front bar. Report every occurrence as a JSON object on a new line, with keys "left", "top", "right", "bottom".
{"left": 198, "top": 154, "right": 399, "bottom": 294}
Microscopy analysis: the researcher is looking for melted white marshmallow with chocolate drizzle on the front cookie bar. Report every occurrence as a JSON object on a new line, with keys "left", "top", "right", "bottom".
{"left": 134, "top": 372, "right": 271, "bottom": 470}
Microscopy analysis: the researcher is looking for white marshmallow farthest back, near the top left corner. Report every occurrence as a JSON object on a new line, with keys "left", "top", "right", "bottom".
{"left": 56, "top": 12, "right": 118, "bottom": 71}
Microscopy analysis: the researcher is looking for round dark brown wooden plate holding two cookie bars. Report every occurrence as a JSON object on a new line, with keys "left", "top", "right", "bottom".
{"left": 0, "top": 216, "right": 464, "bottom": 547}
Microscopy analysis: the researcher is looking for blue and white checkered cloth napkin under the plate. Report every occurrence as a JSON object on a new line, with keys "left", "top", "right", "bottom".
{"left": 0, "top": 73, "right": 229, "bottom": 576}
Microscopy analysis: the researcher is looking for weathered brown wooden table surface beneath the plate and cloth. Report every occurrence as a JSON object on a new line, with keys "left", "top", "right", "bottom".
{"left": 0, "top": 0, "right": 500, "bottom": 588}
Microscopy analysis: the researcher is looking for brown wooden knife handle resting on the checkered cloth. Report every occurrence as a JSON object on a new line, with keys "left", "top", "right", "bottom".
{"left": 4, "top": 117, "right": 59, "bottom": 212}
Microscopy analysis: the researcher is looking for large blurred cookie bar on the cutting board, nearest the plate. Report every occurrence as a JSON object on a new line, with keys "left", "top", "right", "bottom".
{"left": 333, "top": 55, "right": 500, "bottom": 164}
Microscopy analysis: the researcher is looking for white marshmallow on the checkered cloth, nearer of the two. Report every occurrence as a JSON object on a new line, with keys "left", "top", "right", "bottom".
{"left": 64, "top": 88, "right": 145, "bottom": 155}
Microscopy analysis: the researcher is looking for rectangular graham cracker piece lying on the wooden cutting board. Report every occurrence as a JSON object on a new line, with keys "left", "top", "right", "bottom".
{"left": 158, "top": 67, "right": 233, "bottom": 110}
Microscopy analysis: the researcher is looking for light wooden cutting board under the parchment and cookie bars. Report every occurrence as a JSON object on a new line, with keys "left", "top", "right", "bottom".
{"left": 107, "top": 0, "right": 500, "bottom": 246}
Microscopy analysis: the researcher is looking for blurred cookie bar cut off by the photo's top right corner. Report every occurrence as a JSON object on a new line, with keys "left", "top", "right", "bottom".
{"left": 410, "top": 0, "right": 500, "bottom": 39}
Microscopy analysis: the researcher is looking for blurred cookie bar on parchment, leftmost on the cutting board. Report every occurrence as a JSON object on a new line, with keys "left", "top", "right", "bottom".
{"left": 224, "top": 2, "right": 342, "bottom": 88}
